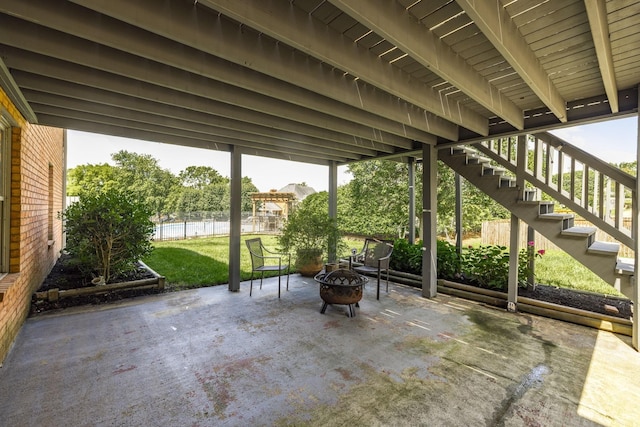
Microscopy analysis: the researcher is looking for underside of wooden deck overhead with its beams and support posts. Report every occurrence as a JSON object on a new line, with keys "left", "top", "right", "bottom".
{"left": 0, "top": 0, "right": 640, "bottom": 348}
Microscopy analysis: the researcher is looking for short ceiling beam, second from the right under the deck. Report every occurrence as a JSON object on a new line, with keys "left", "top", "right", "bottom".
{"left": 456, "top": 0, "right": 567, "bottom": 123}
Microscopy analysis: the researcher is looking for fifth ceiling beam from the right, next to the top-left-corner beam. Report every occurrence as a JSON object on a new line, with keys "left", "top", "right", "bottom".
{"left": 65, "top": 0, "right": 458, "bottom": 143}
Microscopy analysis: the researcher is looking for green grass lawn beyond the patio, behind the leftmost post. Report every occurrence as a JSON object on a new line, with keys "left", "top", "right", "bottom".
{"left": 143, "top": 235, "right": 362, "bottom": 290}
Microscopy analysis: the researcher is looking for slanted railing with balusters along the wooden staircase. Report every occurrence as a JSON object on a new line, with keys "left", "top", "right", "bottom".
{"left": 473, "top": 132, "right": 638, "bottom": 248}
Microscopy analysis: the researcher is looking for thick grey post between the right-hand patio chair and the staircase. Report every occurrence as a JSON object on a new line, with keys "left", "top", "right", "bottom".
{"left": 422, "top": 144, "right": 438, "bottom": 298}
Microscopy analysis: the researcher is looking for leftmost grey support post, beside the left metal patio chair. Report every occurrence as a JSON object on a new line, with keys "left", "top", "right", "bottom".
{"left": 229, "top": 146, "right": 242, "bottom": 292}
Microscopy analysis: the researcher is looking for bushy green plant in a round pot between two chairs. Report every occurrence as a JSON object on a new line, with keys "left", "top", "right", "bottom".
{"left": 278, "top": 204, "right": 344, "bottom": 277}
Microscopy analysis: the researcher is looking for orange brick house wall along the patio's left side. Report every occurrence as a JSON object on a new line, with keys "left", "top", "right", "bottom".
{"left": 0, "top": 88, "right": 64, "bottom": 364}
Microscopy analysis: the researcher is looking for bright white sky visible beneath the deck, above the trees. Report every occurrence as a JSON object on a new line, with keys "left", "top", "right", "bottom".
{"left": 67, "top": 117, "right": 638, "bottom": 192}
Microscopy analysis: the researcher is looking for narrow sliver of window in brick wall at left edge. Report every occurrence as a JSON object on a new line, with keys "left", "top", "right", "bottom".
{"left": 0, "top": 114, "right": 11, "bottom": 274}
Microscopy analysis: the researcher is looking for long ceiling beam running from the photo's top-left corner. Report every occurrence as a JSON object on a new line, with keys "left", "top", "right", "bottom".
{"left": 0, "top": 0, "right": 440, "bottom": 143}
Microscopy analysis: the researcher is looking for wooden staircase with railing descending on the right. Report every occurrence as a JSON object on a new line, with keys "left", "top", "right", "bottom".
{"left": 438, "top": 133, "right": 635, "bottom": 302}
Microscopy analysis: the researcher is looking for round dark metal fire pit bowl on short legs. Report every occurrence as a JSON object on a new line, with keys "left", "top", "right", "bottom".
{"left": 314, "top": 268, "right": 367, "bottom": 317}
